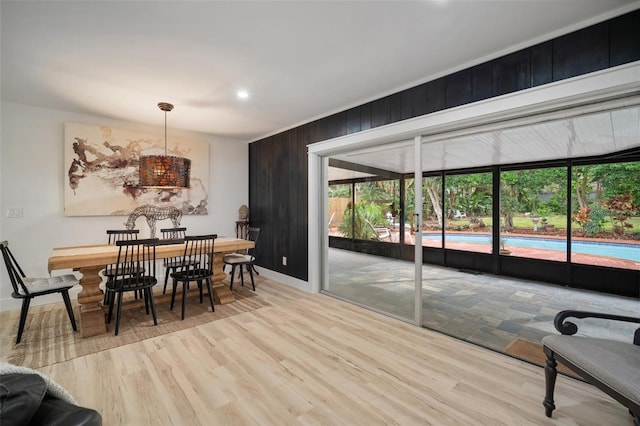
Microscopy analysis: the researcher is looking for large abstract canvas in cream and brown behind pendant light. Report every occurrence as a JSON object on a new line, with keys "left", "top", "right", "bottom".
{"left": 64, "top": 123, "right": 209, "bottom": 216}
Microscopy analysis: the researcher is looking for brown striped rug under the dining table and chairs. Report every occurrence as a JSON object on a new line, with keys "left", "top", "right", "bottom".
{"left": 0, "top": 287, "right": 270, "bottom": 368}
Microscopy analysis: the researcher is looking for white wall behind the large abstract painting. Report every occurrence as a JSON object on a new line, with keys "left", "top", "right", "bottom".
{"left": 0, "top": 102, "right": 249, "bottom": 310}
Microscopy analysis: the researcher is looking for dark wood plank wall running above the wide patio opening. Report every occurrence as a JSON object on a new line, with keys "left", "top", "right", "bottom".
{"left": 249, "top": 10, "right": 640, "bottom": 281}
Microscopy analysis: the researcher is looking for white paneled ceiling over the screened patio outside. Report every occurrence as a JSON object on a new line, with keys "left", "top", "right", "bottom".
{"left": 329, "top": 105, "right": 640, "bottom": 181}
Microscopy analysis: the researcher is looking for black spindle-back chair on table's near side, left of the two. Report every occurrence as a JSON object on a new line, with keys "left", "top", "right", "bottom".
{"left": 105, "top": 238, "right": 158, "bottom": 336}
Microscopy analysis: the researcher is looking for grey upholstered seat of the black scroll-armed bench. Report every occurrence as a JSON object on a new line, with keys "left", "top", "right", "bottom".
{"left": 542, "top": 335, "right": 640, "bottom": 404}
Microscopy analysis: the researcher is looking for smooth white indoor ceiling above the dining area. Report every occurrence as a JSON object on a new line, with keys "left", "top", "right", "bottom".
{"left": 0, "top": 0, "right": 640, "bottom": 141}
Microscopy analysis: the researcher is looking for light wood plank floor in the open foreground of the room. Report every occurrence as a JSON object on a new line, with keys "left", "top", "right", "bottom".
{"left": 35, "top": 277, "right": 632, "bottom": 426}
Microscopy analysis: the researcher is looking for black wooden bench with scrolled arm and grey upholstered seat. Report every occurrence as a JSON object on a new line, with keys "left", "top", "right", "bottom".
{"left": 542, "top": 311, "right": 640, "bottom": 426}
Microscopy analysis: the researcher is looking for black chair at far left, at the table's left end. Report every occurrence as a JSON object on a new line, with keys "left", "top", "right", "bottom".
{"left": 0, "top": 241, "right": 79, "bottom": 345}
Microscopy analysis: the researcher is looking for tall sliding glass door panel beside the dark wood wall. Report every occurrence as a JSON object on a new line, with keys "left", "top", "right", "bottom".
{"left": 321, "top": 141, "right": 421, "bottom": 322}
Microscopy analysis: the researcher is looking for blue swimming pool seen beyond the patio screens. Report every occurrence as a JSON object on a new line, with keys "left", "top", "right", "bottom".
{"left": 422, "top": 233, "right": 640, "bottom": 262}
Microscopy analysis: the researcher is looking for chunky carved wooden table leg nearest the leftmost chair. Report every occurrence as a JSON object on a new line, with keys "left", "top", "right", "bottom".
{"left": 75, "top": 266, "right": 107, "bottom": 337}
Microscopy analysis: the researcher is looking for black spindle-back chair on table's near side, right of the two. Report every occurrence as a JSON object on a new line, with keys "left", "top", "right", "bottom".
{"left": 169, "top": 234, "right": 218, "bottom": 319}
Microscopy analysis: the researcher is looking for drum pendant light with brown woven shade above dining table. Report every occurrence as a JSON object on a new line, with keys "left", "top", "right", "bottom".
{"left": 139, "top": 102, "right": 191, "bottom": 189}
